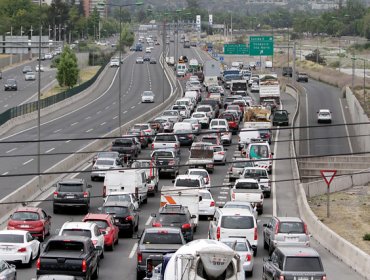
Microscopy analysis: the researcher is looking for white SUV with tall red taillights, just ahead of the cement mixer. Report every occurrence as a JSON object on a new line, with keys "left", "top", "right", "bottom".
{"left": 208, "top": 208, "right": 258, "bottom": 255}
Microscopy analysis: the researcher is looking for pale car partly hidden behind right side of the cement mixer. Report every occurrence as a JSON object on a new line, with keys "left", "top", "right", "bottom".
{"left": 220, "top": 238, "right": 254, "bottom": 277}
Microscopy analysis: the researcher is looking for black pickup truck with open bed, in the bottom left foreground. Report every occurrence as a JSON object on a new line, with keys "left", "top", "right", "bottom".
{"left": 36, "top": 236, "right": 103, "bottom": 279}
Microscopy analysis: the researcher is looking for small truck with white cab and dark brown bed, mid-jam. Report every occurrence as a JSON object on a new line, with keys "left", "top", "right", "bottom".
{"left": 187, "top": 142, "right": 214, "bottom": 173}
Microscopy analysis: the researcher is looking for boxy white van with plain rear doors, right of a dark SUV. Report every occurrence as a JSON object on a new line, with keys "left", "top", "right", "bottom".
{"left": 103, "top": 169, "right": 148, "bottom": 203}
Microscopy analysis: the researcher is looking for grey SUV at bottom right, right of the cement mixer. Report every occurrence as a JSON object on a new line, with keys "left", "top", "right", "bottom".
{"left": 262, "top": 247, "right": 326, "bottom": 280}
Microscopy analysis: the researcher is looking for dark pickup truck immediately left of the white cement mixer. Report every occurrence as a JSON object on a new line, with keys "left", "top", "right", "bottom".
{"left": 136, "top": 227, "right": 186, "bottom": 279}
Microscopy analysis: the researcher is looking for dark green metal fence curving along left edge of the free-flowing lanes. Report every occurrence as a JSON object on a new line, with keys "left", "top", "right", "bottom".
{"left": 0, "top": 61, "right": 109, "bottom": 126}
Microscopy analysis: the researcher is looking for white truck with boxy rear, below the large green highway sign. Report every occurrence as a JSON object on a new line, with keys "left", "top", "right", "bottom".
{"left": 259, "top": 74, "right": 280, "bottom": 104}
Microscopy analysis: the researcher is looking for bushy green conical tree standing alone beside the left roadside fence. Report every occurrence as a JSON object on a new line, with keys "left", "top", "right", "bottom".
{"left": 57, "top": 46, "right": 79, "bottom": 88}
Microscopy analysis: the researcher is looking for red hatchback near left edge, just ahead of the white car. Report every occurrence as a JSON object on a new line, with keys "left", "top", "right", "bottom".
{"left": 7, "top": 206, "right": 51, "bottom": 241}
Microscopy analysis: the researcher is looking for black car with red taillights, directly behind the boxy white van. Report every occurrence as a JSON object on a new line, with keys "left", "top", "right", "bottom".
{"left": 99, "top": 201, "right": 139, "bottom": 237}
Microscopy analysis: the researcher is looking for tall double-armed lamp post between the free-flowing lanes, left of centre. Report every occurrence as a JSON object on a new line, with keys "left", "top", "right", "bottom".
{"left": 98, "top": 2, "right": 143, "bottom": 137}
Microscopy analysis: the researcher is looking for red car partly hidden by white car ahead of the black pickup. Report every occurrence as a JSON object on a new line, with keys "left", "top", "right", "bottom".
{"left": 82, "top": 213, "right": 119, "bottom": 251}
